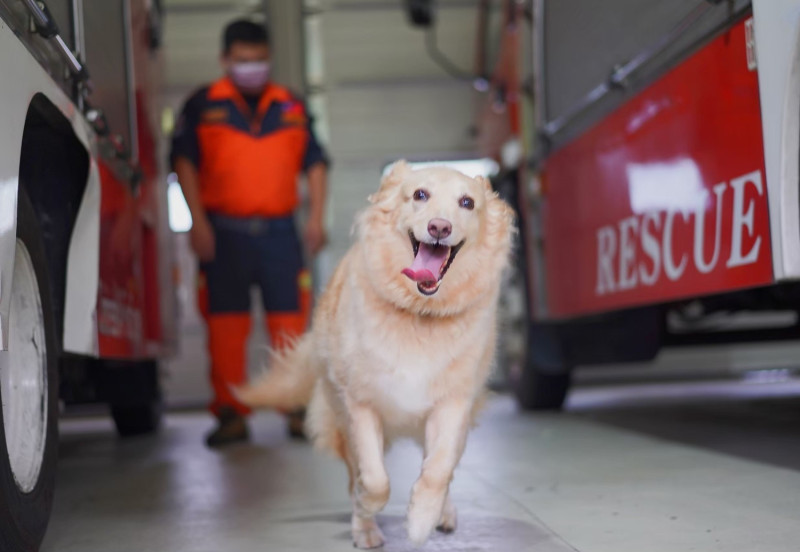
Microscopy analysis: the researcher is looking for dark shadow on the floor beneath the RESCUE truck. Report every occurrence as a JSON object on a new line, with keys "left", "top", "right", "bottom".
{"left": 568, "top": 381, "right": 800, "bottom": 471}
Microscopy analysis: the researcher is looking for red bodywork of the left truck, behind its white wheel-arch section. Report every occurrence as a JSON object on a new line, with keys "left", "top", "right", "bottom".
{"left": 97, "top": 2, "right": 170, "bottom": 359}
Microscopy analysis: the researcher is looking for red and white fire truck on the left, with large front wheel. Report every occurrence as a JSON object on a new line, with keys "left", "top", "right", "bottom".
{"left": 0, "top": 0, "right": 175, "bottom": 551}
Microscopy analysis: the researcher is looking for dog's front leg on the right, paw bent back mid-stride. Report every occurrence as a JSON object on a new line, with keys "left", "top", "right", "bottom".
{"left": 408, "top": 400, "right": 471, "bottom": 546}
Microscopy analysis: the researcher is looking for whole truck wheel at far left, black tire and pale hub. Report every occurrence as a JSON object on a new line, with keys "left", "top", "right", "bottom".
{"left": 0, "top": 191, "right": 58, "bottom": 552}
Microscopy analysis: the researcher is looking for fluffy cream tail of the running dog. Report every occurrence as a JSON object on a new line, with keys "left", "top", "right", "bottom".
{"left": 233, "top": 333, "right": 317, "bottom": 412}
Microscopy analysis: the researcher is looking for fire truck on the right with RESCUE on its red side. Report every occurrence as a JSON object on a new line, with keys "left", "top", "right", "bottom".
{"left": 478, "top": 0, "right": 800, "bottom": 408}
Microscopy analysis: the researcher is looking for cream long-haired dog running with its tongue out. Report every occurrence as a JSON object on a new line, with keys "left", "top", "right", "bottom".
{"left": 238, "top": 161, "right": 514, "bottom": 548}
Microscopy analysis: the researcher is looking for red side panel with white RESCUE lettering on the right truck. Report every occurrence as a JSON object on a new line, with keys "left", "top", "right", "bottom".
{"left": 542, "top": 21, "right": 773, "bottom": 318}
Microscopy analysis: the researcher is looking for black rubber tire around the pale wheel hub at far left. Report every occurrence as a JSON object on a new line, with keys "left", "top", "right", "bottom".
{"left": 0, "top": 190, "right": 58, "bottom": 552}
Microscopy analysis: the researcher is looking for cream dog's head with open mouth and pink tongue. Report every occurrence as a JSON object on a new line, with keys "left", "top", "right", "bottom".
{"left": 358, "top": 161, "right": 514, "bottom": 314}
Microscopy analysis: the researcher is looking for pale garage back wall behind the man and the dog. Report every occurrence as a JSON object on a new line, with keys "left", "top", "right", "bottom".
{"left": 161, "top": 0, "right": 505, "bottom": 406}
